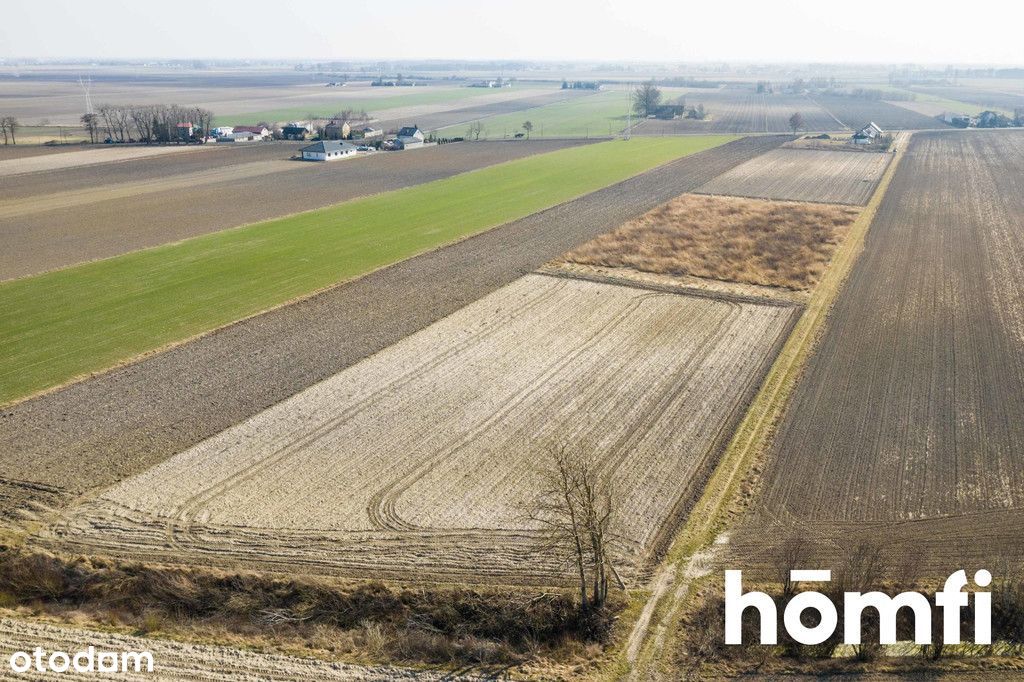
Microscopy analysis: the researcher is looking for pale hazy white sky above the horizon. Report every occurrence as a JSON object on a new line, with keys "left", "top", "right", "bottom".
{"left": 0, "top": 0, "right": 1024, "bottom": 65}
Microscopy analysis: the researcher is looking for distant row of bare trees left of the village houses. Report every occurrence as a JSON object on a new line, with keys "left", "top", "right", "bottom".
{"left": 91, "top": 104, "right": 213, "bottom": 144}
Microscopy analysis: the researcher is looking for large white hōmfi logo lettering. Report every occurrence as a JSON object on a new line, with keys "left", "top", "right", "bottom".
{"left": 725, "top": 569, "right": 992, "bottom": 644}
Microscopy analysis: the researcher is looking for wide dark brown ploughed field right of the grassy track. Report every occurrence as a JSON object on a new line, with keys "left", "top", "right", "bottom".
{"left": 734, "top": 131, "right": 1024, "bottom": 574}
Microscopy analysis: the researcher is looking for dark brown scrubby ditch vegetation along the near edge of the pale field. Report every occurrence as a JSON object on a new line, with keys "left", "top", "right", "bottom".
{"left": 0, "top": 549, "right": 624, "bottom": 666}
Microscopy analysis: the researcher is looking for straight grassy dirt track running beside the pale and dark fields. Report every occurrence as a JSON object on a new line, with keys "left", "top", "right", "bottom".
{"left": 609, "top": 132, "right": 911, "bottom": 680}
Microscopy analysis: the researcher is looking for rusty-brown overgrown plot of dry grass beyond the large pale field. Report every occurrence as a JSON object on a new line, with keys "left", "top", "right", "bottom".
{"left": 564, "top": 195, "right": 858, "bottom": 290}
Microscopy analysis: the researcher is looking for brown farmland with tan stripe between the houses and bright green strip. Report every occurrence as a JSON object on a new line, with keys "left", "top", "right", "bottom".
{"left": 0, "top": 140, "right": 586, "bottom": 280}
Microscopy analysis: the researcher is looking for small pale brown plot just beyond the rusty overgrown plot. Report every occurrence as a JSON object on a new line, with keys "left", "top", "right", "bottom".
{"left": 697, "top": 150, "right": 892, "bottom": 206}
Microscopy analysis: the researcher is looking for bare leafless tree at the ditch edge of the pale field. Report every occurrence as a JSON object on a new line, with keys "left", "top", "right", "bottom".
{"left": 528, "top": 445, "right": 622, "bottom": 610}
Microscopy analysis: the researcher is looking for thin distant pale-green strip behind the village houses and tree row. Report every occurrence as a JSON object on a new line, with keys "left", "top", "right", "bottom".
{"left": 213, "top": 86, "right": 524, "bottom": 126}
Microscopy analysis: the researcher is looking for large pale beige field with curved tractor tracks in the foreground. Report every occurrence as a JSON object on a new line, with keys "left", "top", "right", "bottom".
{"left": 53, "top": 274, "right": 799, "bottom": 581}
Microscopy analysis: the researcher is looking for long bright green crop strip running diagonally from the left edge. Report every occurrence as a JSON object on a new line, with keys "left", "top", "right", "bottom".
{"left": 0, "top": 135, "right": 734, "bottom": 403}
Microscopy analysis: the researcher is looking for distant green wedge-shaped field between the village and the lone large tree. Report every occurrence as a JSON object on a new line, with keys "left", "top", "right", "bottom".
{"left": 440, "top": 90, "right": 629, "bottom": 139}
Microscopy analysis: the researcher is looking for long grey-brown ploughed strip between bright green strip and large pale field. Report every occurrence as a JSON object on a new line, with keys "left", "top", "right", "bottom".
{"left": 0, "top": 137, "right": 788, "bottom": 536}
